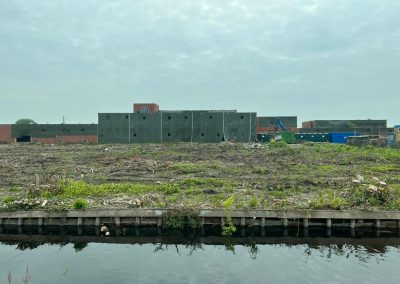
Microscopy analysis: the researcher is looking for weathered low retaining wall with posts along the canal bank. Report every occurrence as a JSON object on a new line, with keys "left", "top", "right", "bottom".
{"left": 0, "top": 209, "right": 400, "bottom": 229}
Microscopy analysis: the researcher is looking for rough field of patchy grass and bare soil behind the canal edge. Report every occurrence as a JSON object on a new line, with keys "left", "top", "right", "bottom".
{"left": 0, "top": 143, "right": 400, "bottom": 210}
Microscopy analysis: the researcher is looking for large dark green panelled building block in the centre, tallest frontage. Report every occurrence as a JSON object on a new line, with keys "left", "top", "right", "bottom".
{"left": 98, "top": 110, "right": 256, "bottom": 143}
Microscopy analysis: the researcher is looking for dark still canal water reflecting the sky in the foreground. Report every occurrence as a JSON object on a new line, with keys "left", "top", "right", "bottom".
{"left": 0, "top": 229, "right": 400, "bottom": 284}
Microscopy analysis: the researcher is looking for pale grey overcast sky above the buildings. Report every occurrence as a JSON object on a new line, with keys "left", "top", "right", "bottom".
{"left": 0, "top": 0, "right": 400, "bottom": 125}
